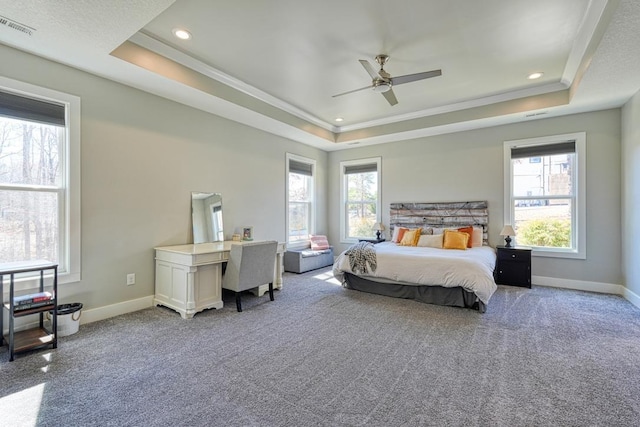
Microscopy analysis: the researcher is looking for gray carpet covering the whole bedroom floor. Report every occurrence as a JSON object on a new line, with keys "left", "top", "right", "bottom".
{"left": 0, "top": 269, "right": 640, "bottom": 426}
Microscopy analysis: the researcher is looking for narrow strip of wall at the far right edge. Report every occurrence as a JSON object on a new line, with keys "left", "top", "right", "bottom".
{"left": 622, "top": 92, "right": 640, "bottom": 303}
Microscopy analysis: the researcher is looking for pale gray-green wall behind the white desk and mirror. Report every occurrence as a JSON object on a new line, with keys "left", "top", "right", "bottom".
{"left": 0, "top": 45, "right": 327, "bottom": 316}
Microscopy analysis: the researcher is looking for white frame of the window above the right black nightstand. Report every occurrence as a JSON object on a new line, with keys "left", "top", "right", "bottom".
{"left": 504, "top": 132, "right": 587, "bottom": 259}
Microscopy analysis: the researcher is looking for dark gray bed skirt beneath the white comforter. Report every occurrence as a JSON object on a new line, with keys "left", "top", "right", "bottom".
{"left": 344, "top": 272, "right": 486, "bottom": 313}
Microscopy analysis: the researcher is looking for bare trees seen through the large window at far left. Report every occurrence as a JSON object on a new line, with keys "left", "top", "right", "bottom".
{"left": 0, "top": 117, "right": 64, "bottom": 262}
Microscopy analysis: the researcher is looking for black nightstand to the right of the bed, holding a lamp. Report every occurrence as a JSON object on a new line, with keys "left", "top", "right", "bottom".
{"left": 494, "top": 246, "right": 531, "bottom": 288}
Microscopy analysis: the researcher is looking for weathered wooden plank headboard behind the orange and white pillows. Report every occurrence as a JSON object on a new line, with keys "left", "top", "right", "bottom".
{"left": 389, "top": 201, "right": 489, "bottom": 245}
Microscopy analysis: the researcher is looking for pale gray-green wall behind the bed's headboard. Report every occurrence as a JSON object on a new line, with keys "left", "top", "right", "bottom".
{"left": 329, "top": 109, "right": 624, "bottom": 285}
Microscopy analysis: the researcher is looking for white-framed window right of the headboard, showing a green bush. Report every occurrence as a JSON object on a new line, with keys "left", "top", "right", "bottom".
{"left": 504, "top": 133, "right": 586, "bottom": 259}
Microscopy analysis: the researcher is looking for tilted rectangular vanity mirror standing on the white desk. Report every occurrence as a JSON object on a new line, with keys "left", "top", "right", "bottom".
{"left": 191, "top": 191, "right": 224, "bottom": 243}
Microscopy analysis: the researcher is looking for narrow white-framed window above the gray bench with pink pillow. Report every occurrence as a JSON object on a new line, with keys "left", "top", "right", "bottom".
{"left": 287, "top": 153, "right": 316, "bottom": 247}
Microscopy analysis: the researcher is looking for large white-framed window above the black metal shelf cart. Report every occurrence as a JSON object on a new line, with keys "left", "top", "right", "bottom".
{"left": 0, "top": 78, "right": 80, "bottom": 283}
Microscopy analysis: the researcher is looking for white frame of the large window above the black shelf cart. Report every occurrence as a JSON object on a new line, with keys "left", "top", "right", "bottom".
{"left": 0, "top": 76, "right": 82, "bottom": 289}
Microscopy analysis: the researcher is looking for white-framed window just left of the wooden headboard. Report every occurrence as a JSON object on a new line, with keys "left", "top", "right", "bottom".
{"left": 340, "top": 157, "right": 381, "bottom": 243}
